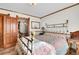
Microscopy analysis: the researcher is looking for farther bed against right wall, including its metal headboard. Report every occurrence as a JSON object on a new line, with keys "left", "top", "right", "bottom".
{"left": 35, "top": 20, "right": 70, "bottom": 55}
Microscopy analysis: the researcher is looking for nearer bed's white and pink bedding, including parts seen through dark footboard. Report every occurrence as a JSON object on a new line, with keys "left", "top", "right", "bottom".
{"left": 18, "top": 37, "right": 56, "bottom": 55}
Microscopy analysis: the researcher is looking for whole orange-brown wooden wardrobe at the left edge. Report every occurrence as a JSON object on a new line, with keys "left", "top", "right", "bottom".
{"left": 0, "top": 14, "right": 18, "bottom": 48}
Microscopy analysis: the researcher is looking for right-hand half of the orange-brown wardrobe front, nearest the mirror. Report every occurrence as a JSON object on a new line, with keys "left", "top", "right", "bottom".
{"left": 11, "top": 17, "right": 18, "bottom": 45}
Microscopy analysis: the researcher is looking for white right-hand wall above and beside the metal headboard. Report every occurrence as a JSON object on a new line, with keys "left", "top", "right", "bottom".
{"left": 41, "top": 5, "right": 79, "bottom": 32}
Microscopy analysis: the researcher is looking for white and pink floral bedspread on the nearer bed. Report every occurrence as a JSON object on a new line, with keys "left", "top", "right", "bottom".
{"left": 33, "top": 40, "right": 56, "bottom": 55}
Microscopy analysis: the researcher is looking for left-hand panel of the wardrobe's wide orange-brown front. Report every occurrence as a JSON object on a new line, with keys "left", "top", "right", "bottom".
{"left": 4, "top": 16, "right": 11, "bottom": 47}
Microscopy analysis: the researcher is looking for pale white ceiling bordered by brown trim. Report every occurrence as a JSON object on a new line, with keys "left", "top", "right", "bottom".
{"left": 0, "top": 3, "right": 73, "bottom": 17}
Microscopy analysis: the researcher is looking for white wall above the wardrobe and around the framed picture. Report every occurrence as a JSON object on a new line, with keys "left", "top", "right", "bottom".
{"left": 0, "top": 10, "right": 40, "bottom": 31}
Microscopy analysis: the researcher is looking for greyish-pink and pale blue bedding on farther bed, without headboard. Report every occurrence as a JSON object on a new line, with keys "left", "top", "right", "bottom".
{"left": 35, "top": 33, "right": 68, "bottom": 55}
